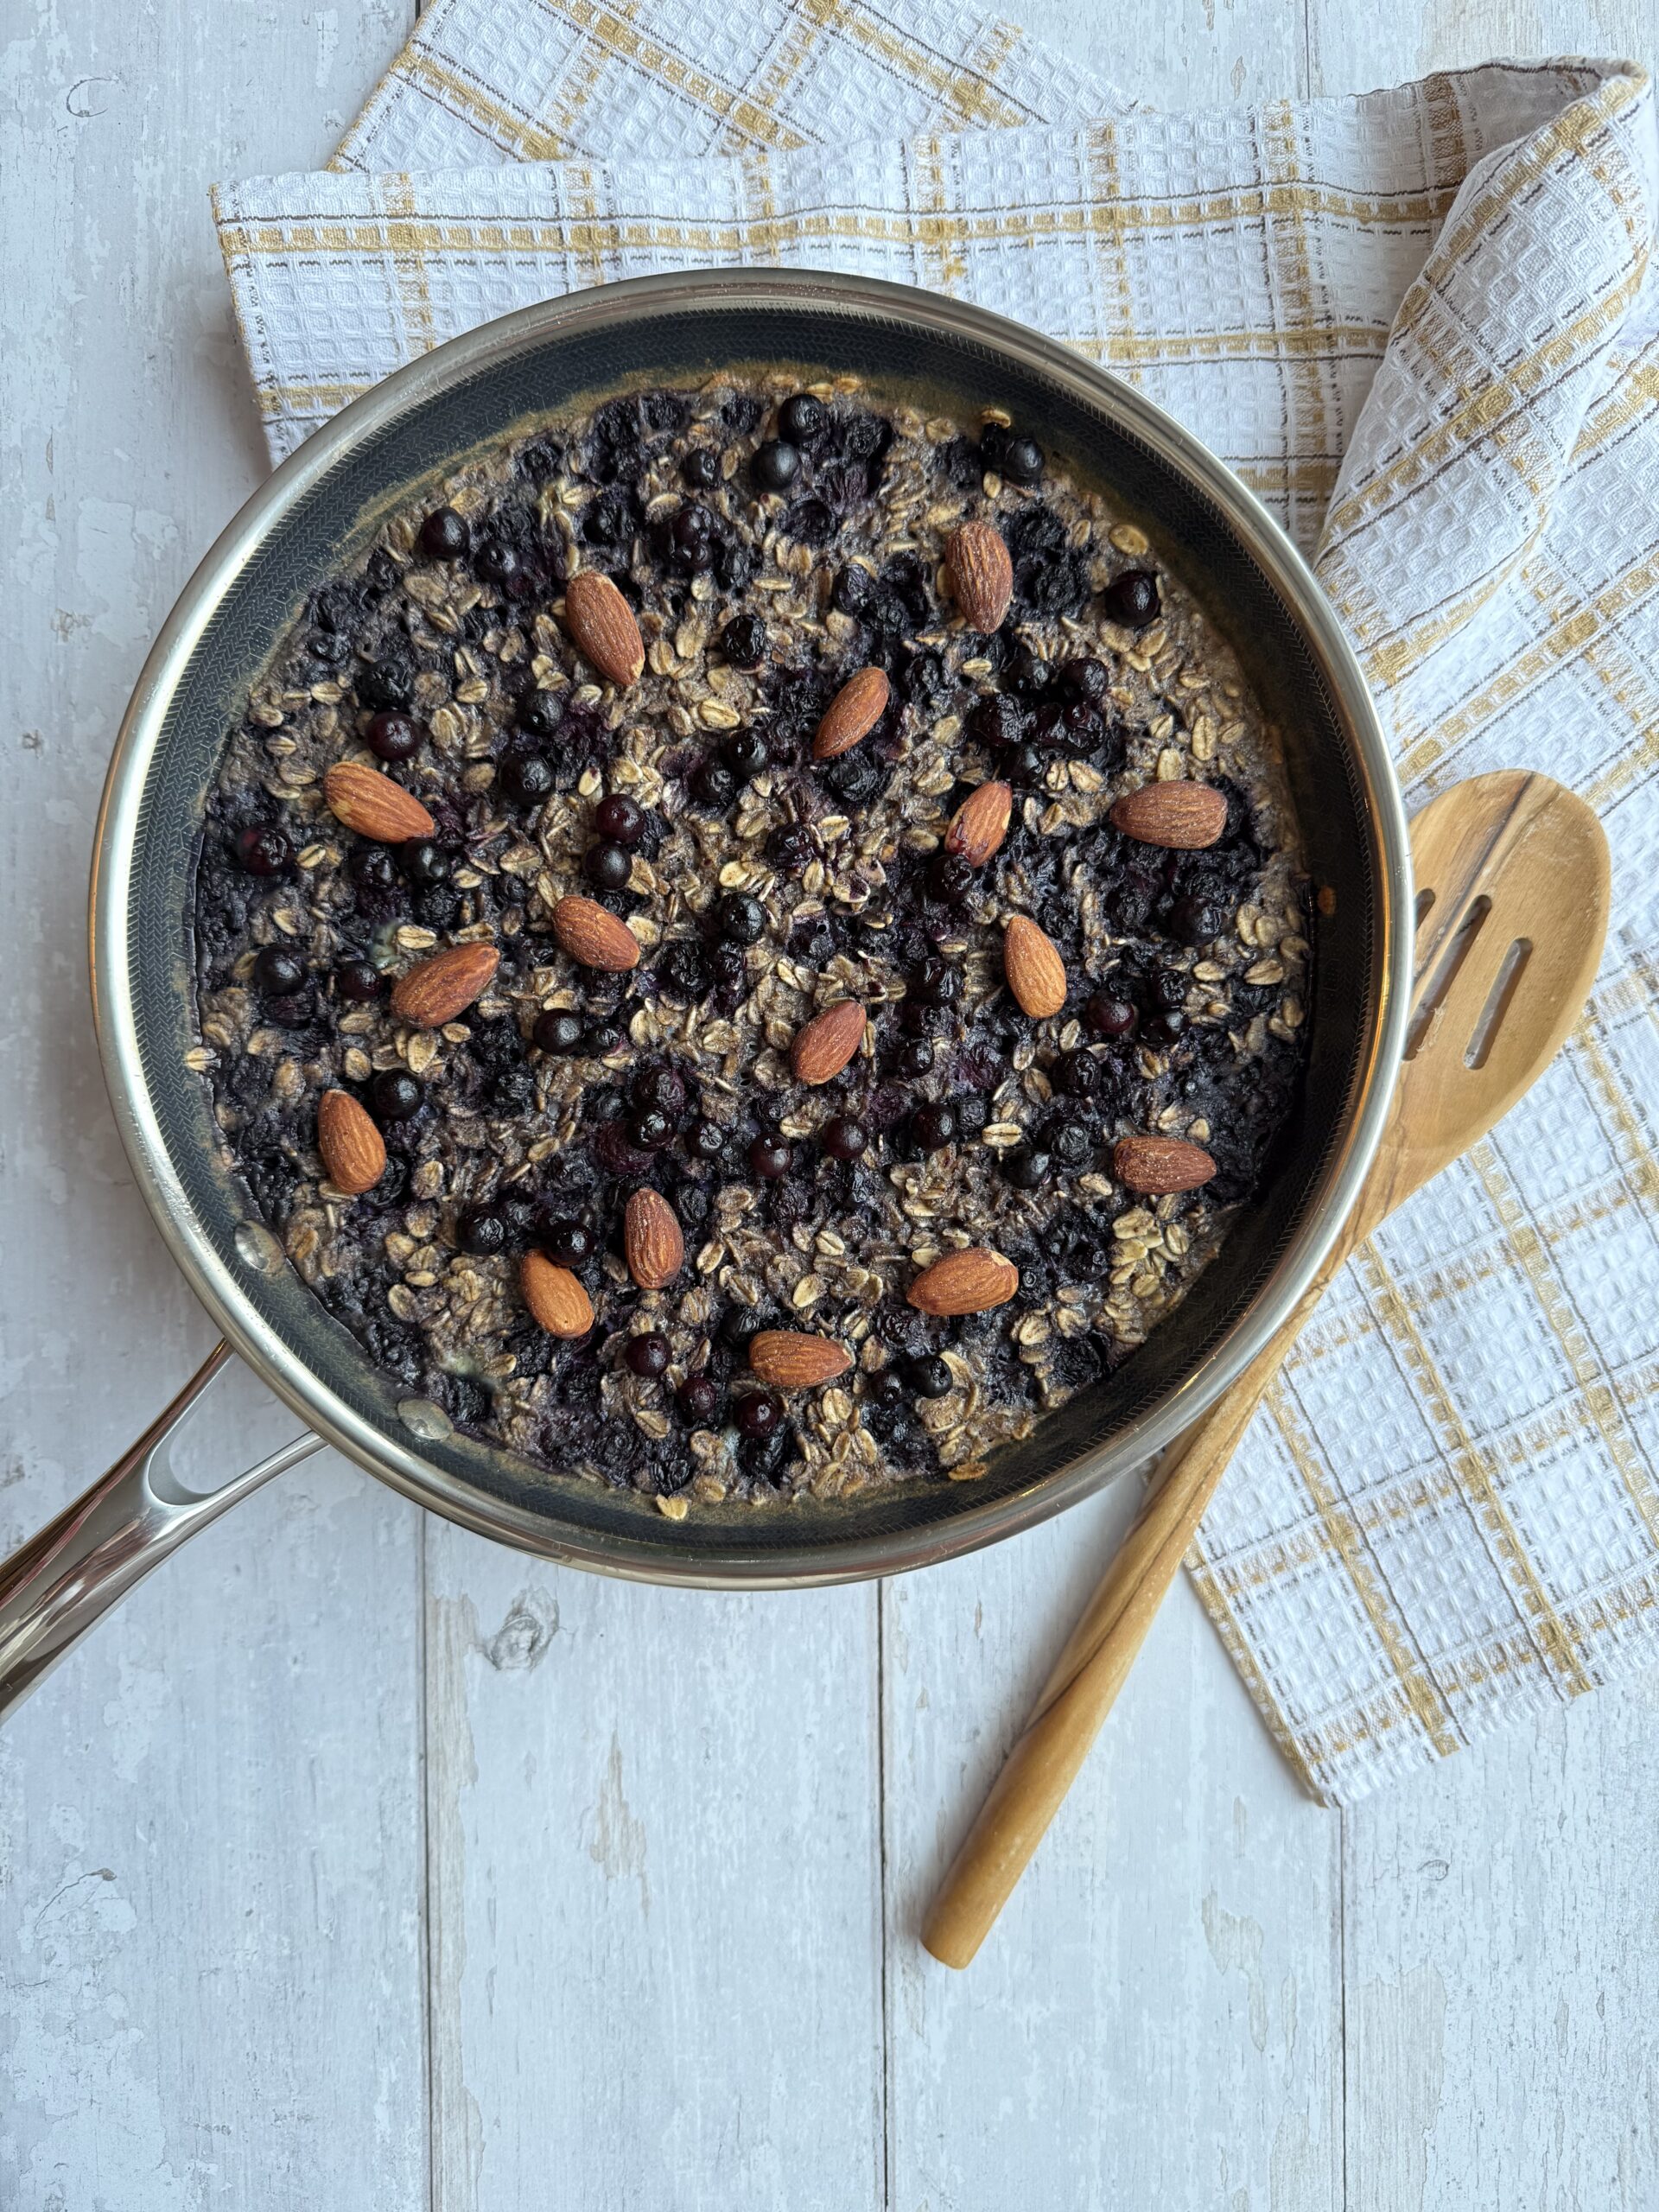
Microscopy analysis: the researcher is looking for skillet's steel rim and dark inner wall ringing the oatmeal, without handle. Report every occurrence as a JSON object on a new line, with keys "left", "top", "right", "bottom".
{"left": 99, "top": 281, "right": 1391, "bottom": 1581}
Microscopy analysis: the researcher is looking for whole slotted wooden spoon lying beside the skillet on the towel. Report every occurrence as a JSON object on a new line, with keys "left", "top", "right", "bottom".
{"left": 923, "top": 770, "right": 1608, "bottom": 1967}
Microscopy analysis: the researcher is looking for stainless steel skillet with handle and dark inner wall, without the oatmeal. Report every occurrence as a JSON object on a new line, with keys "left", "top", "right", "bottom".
{"left": 0, "top": 270, "right": 1411, "bottom": 1710}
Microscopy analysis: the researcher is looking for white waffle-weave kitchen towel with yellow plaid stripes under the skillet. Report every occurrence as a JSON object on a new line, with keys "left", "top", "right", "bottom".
{"left": 217, "top": 0, "right": 1659, "bottom": 1801}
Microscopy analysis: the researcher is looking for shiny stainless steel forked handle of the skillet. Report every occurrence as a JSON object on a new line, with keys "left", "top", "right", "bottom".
{"left": 0, "top": 1344, "right": 323, "bottom": 1719}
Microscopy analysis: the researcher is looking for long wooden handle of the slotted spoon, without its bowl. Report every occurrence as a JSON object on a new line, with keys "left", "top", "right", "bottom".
{"left": 923, "top": 1199, "right": 1387, "bottom": 1967}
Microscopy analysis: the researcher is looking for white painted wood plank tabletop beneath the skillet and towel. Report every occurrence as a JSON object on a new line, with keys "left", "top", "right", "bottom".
{"left": 0, "top": 0, "right": 1659, "bottom": 2212}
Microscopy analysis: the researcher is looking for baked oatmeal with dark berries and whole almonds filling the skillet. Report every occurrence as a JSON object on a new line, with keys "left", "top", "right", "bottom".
{"left": 190, "top": 367, "right": 1310, "bottom": 1517}
